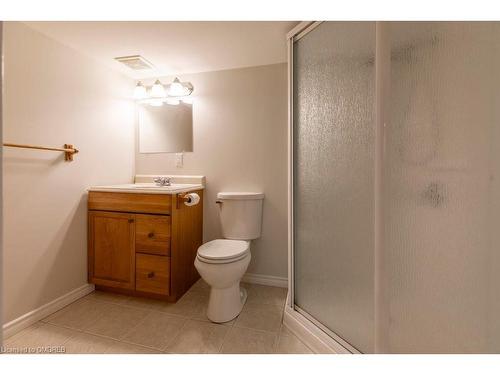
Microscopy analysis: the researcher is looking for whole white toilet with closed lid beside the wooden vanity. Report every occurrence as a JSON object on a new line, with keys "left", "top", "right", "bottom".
{"left": 194, "top": 192, "right": 264, "bottom": 323}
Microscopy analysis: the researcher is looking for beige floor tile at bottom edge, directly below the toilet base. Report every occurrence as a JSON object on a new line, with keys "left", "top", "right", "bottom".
{"left": 221, "top": 327, "right": 277, "bottom": 354}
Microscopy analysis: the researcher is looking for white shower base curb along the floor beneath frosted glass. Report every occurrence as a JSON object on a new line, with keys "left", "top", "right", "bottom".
{"left": 283, "top": 299, "right": 350, "bottom": 354}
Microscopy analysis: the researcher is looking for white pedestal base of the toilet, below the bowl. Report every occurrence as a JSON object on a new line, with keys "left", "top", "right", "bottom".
{"left": 207, "top": 282, "right": 247, "bottom": 323}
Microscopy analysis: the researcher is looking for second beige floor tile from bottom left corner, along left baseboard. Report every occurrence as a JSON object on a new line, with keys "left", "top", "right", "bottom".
{"left": 44, "top": 299, "right": 113, "bottom": 330}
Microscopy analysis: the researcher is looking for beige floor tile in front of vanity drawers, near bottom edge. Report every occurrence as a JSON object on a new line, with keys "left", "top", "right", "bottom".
{"left": 123, "top": 311, "right": 186, "bottom": 350}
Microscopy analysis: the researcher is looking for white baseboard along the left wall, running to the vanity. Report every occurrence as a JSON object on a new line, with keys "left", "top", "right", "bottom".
{"left": 3, "top": 284, "right": 94, "bottom": 340}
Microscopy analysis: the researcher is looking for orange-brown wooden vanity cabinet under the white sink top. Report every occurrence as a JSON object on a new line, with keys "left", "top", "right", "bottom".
{"left": 88, "top": 190, "right": 203, "bottom": 301}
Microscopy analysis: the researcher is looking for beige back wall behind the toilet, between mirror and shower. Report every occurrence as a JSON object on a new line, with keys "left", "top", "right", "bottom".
{"left": 136, "top": 64, "right": 287, "bottom": 277}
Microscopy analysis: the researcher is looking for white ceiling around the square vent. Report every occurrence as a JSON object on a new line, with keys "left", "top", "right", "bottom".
{"left": 26, "top": 21, "right": 297, "bottom": 79}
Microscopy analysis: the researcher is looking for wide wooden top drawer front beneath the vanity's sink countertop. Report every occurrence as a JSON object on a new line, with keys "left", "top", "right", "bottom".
{"left": 88, "top": 191, "right": 172, "bottom": 214}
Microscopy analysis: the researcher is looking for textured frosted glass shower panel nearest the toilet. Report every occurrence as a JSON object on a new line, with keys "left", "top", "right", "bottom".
{"left": 293, "top": 22, "right": 375, "bottom": 352}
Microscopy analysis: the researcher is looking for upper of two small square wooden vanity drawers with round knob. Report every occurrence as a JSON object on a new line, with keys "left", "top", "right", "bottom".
{"left": 135, "top": 215, "right": 171, "bottom": 256}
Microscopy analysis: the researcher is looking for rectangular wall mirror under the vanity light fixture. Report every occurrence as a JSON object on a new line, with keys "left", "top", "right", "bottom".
{"left": 139, "top": 102, "right": 193, "bottom": 154}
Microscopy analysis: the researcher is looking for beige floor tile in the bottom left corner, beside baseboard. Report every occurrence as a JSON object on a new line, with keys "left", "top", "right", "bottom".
{"left": 5, "top": 322, "right": 77, "bottom": 354}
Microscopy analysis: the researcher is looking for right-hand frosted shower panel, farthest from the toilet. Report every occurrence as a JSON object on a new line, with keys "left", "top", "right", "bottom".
{"left": 384, "top": 22, "right": 500, "bottom": 353}
